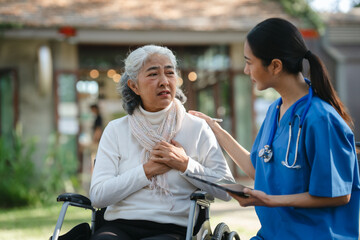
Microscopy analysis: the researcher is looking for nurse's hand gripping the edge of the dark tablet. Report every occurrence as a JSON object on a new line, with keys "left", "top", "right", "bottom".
{"left": 228, "top": 188, "right": 272, "bottom": 207}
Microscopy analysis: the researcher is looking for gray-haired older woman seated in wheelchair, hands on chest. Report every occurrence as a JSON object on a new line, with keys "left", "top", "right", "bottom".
{"left": 90, "top": 45, "right": 233, "bottom": 240}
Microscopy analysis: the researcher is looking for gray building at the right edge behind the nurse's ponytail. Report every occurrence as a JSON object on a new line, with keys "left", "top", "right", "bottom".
{"left": 321, "top": 7, "right": 360, "bottom": 139}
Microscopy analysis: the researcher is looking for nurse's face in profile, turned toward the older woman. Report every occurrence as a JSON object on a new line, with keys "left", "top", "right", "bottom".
{"left": 244, "top": 41, "right": 271, "bottom": 90}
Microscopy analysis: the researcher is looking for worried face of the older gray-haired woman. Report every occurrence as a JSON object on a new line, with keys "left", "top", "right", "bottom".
{"left": 128, "top": 54, "right": 176, "bottom": 112}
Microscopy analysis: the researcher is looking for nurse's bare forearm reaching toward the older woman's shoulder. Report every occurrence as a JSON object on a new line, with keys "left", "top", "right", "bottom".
{"left": 209, "top": 121, "right": 255, "bottom": 179}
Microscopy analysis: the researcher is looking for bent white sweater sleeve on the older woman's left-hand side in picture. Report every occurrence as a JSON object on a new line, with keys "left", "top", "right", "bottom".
{"left": 90, "top": 122, "right": 149, "bottom": 208}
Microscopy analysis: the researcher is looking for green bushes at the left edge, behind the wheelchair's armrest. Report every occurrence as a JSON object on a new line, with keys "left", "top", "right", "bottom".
{"left": 0, "top": 129, "right": 79, "bottom": 208}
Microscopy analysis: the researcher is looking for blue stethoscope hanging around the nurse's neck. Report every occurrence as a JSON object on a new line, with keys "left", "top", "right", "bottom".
{"left": 259, "top": 79, "right": 313, "bottom": 169}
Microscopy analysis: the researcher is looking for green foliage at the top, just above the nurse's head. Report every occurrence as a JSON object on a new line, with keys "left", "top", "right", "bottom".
{"left": 275, "top": 0, "right": 325, "bottom": 33}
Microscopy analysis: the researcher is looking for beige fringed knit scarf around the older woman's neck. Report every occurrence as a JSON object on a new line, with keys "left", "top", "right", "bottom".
{"left": 129, "top": 98, "right": 186, "bottom": 196}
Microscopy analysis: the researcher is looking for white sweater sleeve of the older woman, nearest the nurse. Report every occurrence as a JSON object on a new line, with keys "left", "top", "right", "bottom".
{"left": 182, "top": 119, "right": 235, "bottom": 201}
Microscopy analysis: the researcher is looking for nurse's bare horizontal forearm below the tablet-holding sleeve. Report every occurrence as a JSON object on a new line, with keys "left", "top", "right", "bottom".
{"left": 270, "top": 192, "right": 351, "bottom": 208}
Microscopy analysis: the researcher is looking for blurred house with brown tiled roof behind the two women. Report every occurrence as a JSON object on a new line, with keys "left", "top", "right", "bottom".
{"left": 0, "top": 0, "right": 354, "bottom": 180}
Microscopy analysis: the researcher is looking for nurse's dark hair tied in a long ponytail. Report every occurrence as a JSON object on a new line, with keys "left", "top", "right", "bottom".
{"left": 246, "top": 18, "right": 353, "bottom": 127}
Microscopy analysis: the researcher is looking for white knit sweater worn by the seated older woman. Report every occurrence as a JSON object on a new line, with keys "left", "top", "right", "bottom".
{"left": 90, "top": 109, "right": 233, "bottom": 226}
